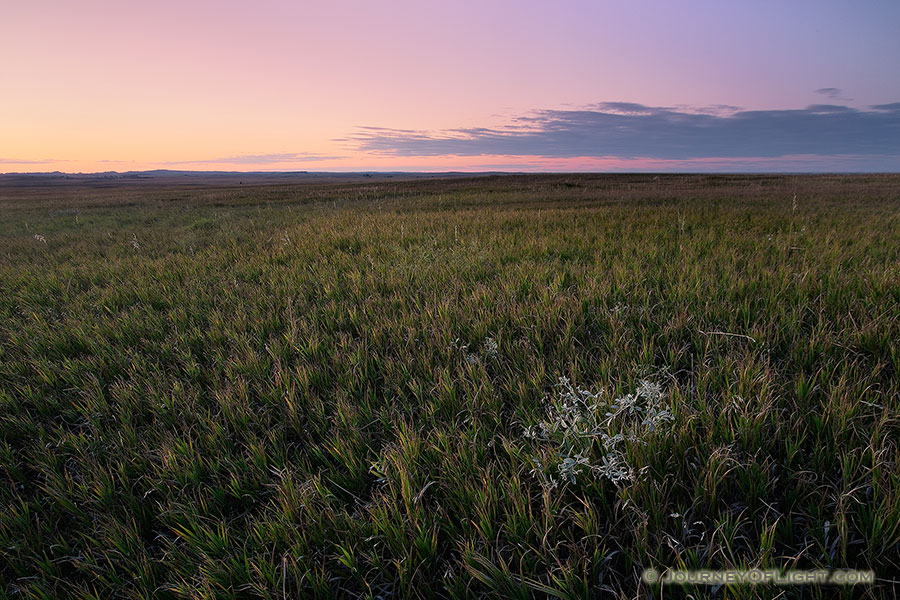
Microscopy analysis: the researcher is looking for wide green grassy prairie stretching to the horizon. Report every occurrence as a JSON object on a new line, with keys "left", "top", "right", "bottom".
{"left": 0, "top": 175, "right": 900, "bottom": 598}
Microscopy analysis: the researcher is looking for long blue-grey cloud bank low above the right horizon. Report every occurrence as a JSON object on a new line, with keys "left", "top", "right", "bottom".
{"left": 344, "top": 102, "right": 900, "bottom": 160}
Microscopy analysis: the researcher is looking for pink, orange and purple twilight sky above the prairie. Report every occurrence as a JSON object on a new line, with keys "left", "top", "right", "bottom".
{"left": 0, "top": 0, "right": 900, "bottom": 172}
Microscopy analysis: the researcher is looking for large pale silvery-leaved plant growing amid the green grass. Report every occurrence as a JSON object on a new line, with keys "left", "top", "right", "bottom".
{"left": 524, "top": 377, "right": 675, "bottom": 489}
